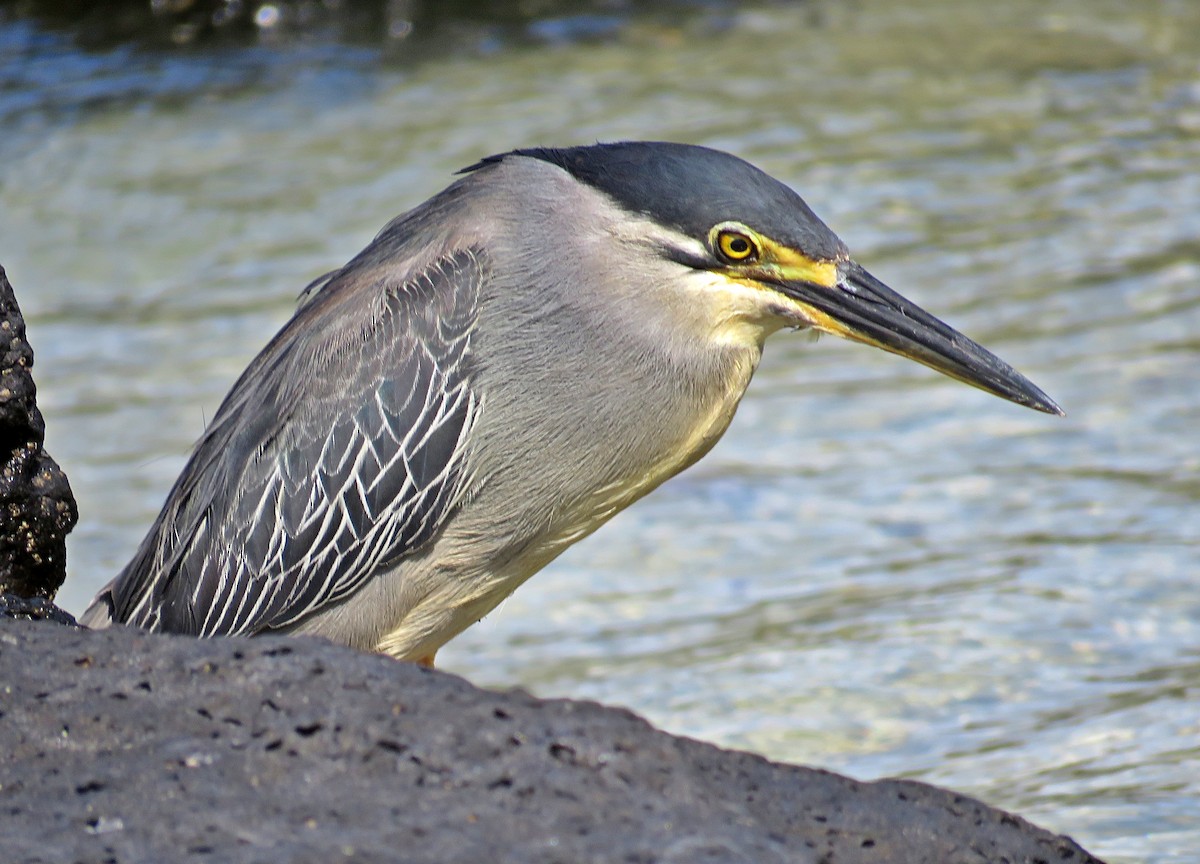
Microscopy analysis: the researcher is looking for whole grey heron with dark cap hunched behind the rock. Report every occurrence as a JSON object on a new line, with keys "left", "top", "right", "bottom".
{"left": 83, "top": 142, "right": 1061, "bottom": 664}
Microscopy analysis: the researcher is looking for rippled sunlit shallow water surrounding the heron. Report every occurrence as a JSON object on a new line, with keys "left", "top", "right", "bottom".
{"left": 0, "top": 0, "right": 1200, "bottom": 862}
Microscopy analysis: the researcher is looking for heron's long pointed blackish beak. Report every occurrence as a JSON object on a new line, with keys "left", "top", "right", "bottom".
{"left": 779, "top": 262, "right": 1063, "bottom": 415}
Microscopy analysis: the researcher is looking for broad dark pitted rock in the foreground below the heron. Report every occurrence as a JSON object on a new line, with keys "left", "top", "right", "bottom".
{"left": 0, "top": 618, "right": 1096, "bottom": 864}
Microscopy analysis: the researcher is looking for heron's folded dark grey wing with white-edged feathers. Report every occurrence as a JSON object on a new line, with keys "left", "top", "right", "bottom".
{"left": 110, "top": 250, "right": 485, "bottom": 636}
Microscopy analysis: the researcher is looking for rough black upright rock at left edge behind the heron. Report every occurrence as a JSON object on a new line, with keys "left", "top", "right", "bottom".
{"left": 0, "top": 268, "right": 79, "bottom": 600}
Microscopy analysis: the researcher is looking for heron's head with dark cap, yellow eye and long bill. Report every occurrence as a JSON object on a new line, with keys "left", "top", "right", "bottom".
{"left": 468, "top": 142, "right": 1062, "bottom": 414}
